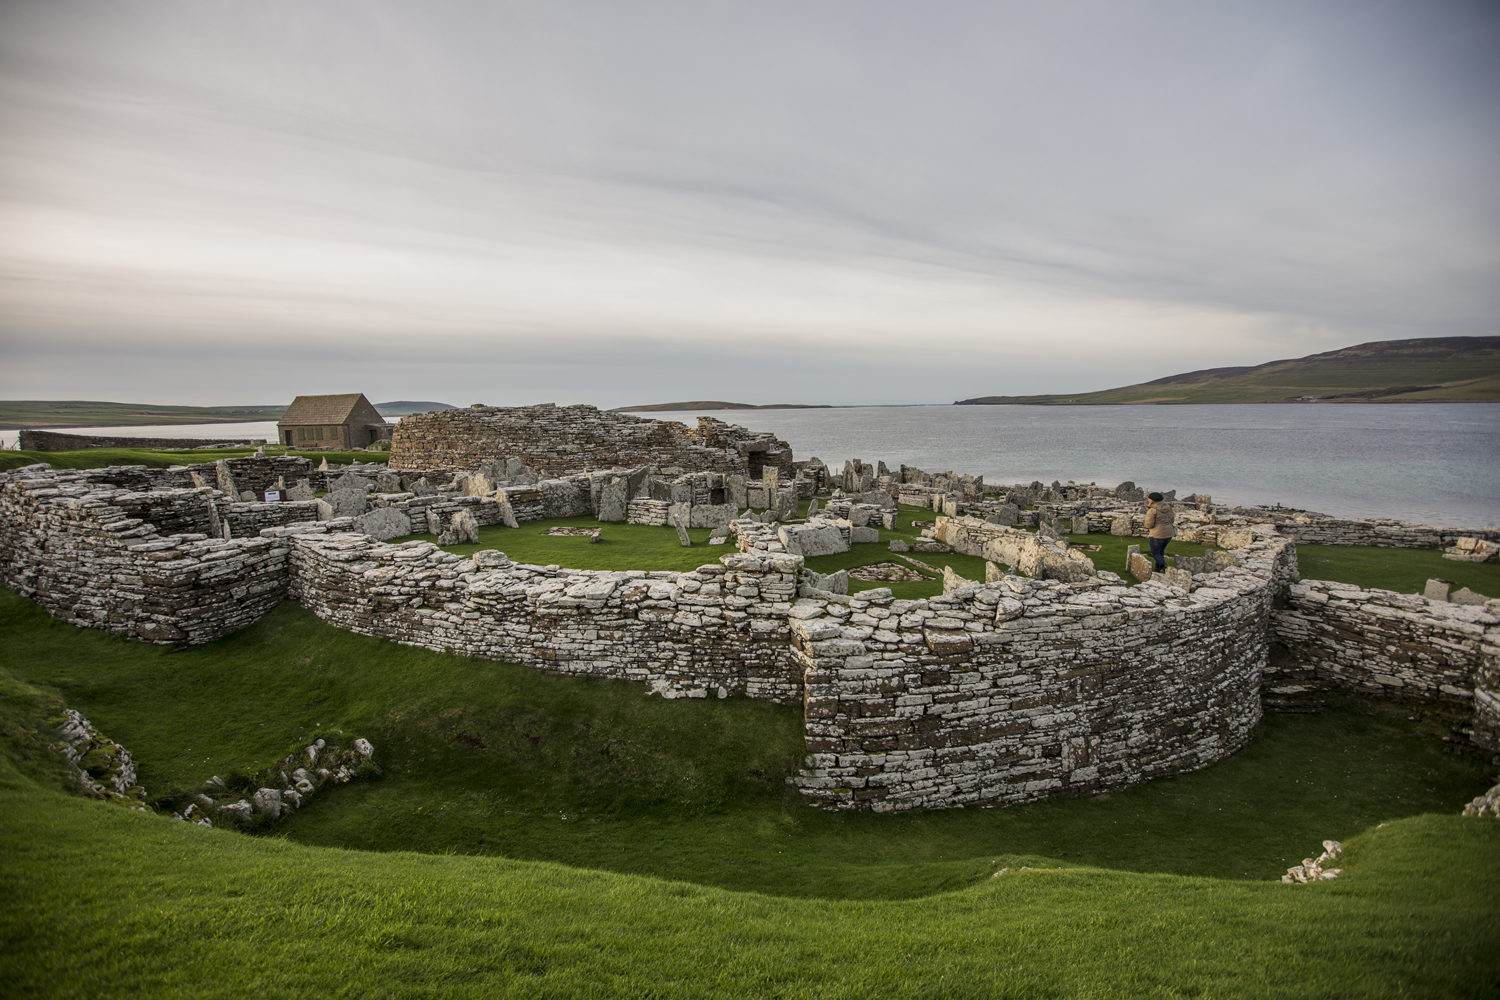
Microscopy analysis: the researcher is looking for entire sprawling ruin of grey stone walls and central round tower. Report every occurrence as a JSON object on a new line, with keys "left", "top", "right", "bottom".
{"left": 0, "top": 406, "right": 1500, "bottom": 811}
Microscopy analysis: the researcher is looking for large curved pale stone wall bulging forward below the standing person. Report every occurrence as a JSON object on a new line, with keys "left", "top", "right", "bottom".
{"left": 792, "top": 532, "right": 1292, "bottom": 811}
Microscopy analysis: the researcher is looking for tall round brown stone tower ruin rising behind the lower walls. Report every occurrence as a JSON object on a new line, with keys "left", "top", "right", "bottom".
{"left": 390, "top": 403, "right": 792, "bottom": 475}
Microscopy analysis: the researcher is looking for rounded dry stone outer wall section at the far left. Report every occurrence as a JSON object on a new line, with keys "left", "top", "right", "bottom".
{"left": 0, "top": 480, "right": 287, "bottom": 643}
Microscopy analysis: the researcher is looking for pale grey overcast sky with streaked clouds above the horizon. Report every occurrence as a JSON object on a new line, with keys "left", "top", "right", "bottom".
{"left": 0, "top": 0, "right": 1500, "bottom": 406}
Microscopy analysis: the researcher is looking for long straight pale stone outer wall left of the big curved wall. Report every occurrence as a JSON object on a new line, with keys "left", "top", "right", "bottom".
{"left": 286, "top": 525, "right": 803, "bottom": 702}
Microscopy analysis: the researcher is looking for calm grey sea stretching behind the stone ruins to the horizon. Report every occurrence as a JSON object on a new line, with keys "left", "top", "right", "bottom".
{"left": 0, "top": 403, "right": 1500, "bottom": 528}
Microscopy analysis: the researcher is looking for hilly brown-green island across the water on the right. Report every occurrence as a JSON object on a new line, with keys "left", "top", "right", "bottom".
{"left": 954, "top": 337, "right": 1500, "bottom": 406}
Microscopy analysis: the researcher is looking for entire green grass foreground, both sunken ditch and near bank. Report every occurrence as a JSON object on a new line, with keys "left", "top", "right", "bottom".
{"left": 0, "top": 581, "right": 1500, "bottom": 997}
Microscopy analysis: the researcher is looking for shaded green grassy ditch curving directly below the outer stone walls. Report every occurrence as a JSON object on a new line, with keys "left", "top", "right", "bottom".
{"left": 0, "top": 594, "right": 1488, "bottom": 898}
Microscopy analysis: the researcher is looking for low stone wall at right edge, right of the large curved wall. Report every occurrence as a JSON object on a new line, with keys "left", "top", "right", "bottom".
{"left": 1269, "top": 580, "right": 1500, "bottom": 750}
